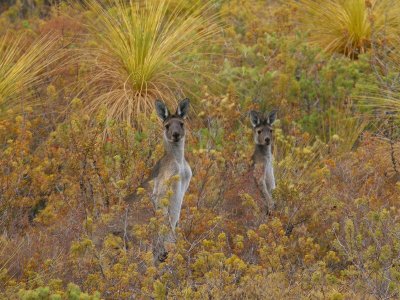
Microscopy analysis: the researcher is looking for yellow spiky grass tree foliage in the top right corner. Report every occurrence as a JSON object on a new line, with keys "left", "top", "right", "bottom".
{"left": 299, "top": 0, "right": 400, "bottom": 58}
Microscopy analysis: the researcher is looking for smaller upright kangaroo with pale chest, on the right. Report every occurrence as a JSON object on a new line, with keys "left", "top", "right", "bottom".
{"left": 250, "top": 110, "right": 277, "bottom": 213}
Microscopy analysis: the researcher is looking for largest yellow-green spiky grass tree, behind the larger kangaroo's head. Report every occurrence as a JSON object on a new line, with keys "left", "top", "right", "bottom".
{"left": 81, "top": 0, "right": 218, "bottom": 126}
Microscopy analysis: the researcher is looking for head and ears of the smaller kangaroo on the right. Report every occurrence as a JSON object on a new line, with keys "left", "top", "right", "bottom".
{"left": 250, "top": 110, "right": 277, "bottom": 146}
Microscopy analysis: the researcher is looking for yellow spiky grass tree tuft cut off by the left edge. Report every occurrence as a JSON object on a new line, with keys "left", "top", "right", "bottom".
{"left": 0, "top": 34, "right": 60, "bottom": 117}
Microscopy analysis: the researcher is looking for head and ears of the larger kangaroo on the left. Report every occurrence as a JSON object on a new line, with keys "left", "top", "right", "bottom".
{"left": 156, "top": 98, "right": 189, "bottom": 143}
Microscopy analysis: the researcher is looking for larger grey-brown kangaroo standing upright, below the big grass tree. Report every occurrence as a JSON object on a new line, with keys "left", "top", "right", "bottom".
{"left": 150, "top": 99, "right": 192, "bottom": 261}
